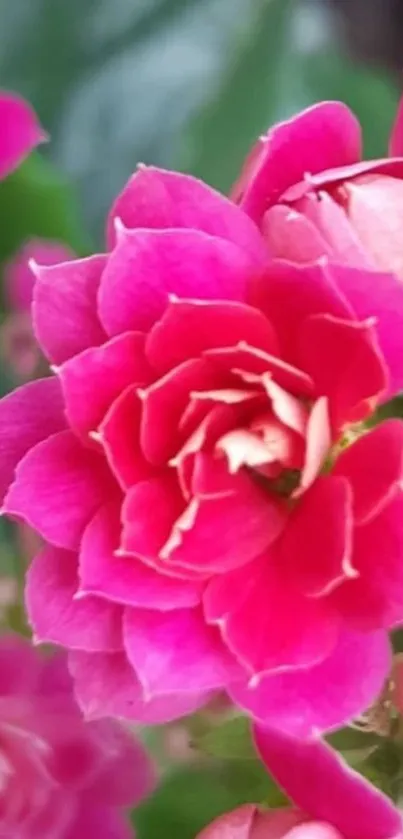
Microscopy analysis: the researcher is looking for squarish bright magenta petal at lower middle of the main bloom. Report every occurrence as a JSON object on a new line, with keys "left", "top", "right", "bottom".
{"left": 124, "top": 608, "right": 242, "bottom": 699}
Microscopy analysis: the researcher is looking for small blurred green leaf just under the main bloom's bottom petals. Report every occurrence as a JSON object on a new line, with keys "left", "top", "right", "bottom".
{"left": 193, "top": 716, "right": 256, "bottom": 760}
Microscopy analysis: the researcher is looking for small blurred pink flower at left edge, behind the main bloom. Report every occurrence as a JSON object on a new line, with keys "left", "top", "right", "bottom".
{"left": 0, "top": 239, "right": 73, "bottom": 381}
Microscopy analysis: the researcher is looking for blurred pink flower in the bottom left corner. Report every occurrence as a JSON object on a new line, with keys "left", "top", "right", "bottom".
{"left": 0, "top": 636, "right": 154, "bottom": 839}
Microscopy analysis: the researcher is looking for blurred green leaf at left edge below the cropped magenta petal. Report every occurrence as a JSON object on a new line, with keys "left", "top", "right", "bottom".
{"left": 0, "top": 153, "right": 89, "bottom": 261}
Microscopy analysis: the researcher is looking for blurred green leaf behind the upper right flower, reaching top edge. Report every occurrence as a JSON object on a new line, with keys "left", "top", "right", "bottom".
{"left": 183, "top": 0, "right": 398, "bottom": 191}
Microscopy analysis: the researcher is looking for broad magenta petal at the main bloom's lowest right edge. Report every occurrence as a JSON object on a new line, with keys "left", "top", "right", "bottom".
{"left": 230, "top": 631, "right": 391, "bottom": 739}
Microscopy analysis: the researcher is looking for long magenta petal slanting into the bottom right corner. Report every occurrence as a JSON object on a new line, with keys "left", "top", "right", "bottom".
{"left": 254, "top": 726, "right": 403, "bottom": 839}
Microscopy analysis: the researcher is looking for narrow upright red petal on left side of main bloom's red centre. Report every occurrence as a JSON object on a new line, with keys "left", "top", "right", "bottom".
{"left": 99, "top": 385, "right": 155, "bottom": 489}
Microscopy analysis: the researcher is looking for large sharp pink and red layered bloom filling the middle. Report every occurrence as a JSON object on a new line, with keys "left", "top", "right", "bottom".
{"left": 0, "top": 168, "right": 403, "bottom": 736}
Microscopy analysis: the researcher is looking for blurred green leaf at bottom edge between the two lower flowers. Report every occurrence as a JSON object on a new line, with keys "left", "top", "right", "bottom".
{"left": 133, "top": 761, "right": 285, "bottom": 839}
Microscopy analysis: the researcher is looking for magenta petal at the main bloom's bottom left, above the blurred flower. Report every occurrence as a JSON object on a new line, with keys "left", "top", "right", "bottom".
{"left": 69, "top": 652, "right": 210, "bottom": 725}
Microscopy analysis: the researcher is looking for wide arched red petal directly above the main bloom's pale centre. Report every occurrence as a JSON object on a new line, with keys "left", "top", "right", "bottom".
{"left": 146, "top": 299, "right": 278, "bottom": 373}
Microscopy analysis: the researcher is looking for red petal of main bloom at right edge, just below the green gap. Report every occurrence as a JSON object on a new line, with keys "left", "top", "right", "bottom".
{"left": 333, "top": 419, "right": 403, "bottom": 524}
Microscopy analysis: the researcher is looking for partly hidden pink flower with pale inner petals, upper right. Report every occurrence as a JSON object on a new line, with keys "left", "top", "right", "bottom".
{"left": 233, "top": 94, "right": 403, "bottom": 279}
